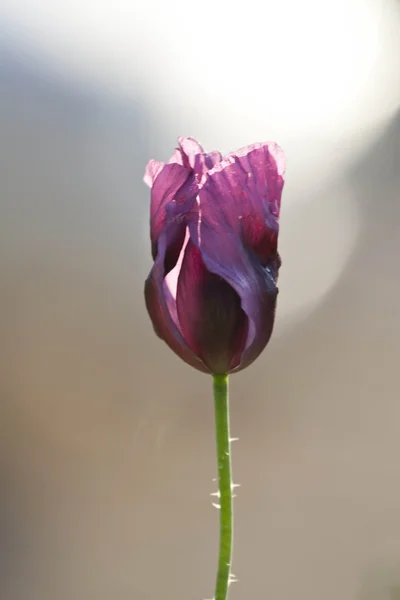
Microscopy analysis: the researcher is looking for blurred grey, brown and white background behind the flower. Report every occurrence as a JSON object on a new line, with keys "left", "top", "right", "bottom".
{"left": 0, "top": 0, "right": 400, "bottom": 600}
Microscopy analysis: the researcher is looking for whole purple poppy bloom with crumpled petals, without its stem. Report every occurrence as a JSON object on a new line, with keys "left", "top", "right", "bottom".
{"left": 144, "top": 138, "right": 285, "bottom": 374}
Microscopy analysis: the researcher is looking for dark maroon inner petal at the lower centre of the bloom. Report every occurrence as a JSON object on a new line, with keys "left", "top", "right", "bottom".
{"left": 176, "top": 240, "right": 247, "bottom": 373}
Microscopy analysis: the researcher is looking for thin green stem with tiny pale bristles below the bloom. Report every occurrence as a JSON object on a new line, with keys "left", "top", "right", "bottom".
{"left": 213, "top": 375, "right": 233, "bottom": 600}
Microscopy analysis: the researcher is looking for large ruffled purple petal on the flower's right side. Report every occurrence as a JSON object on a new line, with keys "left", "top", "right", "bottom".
{"left": 190, "top": 144, "right": 283, "bottom": 368}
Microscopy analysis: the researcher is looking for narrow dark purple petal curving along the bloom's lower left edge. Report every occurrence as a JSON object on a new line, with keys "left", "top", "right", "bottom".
{"left": 145, "top": 228, "right": 209, "bottom": 373}
